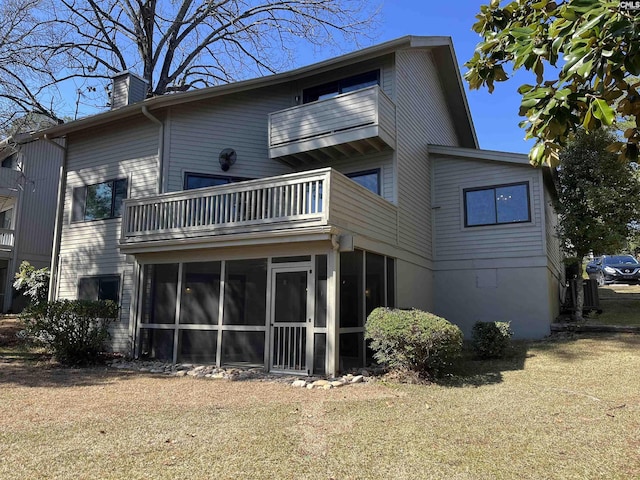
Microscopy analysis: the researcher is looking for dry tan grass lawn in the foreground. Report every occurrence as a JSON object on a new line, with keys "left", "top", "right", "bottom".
{"left": 0, "top": 320, "right": 640, "bottom": 480}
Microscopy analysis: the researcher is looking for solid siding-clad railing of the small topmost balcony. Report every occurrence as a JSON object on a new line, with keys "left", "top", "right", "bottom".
{"left": 269, "top": 85, "right": 395, "bottom": 148}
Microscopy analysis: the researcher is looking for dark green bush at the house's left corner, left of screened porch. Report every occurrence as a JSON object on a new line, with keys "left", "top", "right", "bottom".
{"left": 22, "top": 300, "right": 118, "bottom": 365}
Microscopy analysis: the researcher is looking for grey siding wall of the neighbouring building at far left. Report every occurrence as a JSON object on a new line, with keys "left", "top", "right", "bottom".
{"left": 15, "top": 140, "right": 64, "bottom": 266}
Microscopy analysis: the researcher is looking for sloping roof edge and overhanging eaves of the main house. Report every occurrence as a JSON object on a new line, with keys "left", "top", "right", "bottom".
{"left": 37, "top": 35, "right": 478, "bottom": 148}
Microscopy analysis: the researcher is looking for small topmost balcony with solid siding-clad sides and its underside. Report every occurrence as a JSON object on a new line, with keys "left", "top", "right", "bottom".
{"left": 269, "top": 85, "right": 396, "bottom": 166}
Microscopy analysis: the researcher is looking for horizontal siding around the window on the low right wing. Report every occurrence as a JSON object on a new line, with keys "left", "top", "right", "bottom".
{"left": 432, "top": 157, "right": 546, "bottom": 261}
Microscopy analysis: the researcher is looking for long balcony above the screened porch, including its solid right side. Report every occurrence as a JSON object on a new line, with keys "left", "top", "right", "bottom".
{"left": 120, "top": 168, "right": 397, "bottom": 253}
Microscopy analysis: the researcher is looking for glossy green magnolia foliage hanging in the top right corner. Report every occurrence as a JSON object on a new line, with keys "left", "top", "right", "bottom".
{"left": 465, "top": 0, "right": 640, "bottom": 165}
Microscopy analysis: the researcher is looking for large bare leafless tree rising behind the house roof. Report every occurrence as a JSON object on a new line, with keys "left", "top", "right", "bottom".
{"left": 0, "top": 0, "right": 377, "bottom": 131}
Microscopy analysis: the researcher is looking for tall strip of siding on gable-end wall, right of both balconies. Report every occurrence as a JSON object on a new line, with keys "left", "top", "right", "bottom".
{"left": 396, "top": 50, "right": 458, "bottom": 258}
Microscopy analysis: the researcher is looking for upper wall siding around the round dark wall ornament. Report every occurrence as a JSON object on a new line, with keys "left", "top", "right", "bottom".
{"left": 165, "top": 85, "right": 293, "bottom": 192}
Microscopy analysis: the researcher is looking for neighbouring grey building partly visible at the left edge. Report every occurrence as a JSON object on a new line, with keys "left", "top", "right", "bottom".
{"left": 0, "top": 134, "right": 63, "bottom": 313}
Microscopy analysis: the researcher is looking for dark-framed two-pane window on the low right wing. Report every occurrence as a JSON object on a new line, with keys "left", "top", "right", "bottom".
{"left": 463, "top": 182, "right": 531, "bottom": 227}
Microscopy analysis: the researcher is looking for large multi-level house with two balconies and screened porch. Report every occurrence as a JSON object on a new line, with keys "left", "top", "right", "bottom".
{"left": 41, "top": 36, "right": 561, "bottom": 374}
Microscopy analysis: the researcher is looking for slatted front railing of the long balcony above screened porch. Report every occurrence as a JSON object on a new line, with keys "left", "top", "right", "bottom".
{"left": 122, "top": 168, "right": 331, "bottom": 242}
